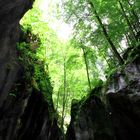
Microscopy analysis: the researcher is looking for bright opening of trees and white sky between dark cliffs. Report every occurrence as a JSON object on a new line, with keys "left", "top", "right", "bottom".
{"left": 21, "top": 0, "right": 138, "bottom": 132}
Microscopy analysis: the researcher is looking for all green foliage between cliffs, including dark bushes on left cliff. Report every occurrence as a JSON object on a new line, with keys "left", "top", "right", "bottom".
{"left": 17, "top": 0, "right": 140, "bottom": 132}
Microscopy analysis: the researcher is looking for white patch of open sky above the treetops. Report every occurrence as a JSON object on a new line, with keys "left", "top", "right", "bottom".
{"left": 39, "top": 0, "right": 72, "bottom": 41}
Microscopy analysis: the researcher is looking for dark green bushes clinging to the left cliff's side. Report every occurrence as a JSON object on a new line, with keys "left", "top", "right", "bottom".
{"left": 17, "top": 29, "right": 52, "bottom": 101}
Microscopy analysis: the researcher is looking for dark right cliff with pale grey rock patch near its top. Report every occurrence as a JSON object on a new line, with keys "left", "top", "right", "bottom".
{"left": 66, "top": 48, "right": 140, "bottom": 140}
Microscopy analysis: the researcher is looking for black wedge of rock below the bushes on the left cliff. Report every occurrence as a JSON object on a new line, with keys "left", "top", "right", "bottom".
{"left": 17, "top": 90, "right": 61, "bottom": 140}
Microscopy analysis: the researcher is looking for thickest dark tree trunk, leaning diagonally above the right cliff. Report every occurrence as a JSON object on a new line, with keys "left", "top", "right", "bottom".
{"left": 90, "top": 2, "right": 124, "bottom": 64}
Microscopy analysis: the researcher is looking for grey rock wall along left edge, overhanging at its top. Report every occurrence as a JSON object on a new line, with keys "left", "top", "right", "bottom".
{"left": 0, "top": 0, "right": 33, "bottom": 140}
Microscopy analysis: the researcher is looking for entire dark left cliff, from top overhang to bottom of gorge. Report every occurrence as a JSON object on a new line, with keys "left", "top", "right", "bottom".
{"left": 0, "top": 0, "right": 60, "bottom": 140}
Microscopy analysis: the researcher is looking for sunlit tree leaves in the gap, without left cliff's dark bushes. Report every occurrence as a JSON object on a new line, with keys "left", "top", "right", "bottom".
{"left": 21, "top": 0, "right": 139, "bottom": 130}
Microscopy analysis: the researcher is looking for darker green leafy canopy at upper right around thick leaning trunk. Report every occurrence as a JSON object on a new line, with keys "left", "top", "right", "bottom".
{"left": 64, "top": 0, "right": 140, "bottom": 65}
